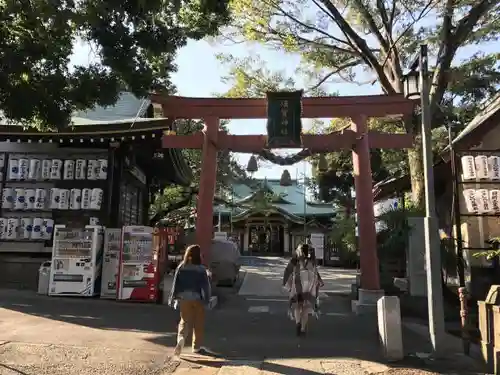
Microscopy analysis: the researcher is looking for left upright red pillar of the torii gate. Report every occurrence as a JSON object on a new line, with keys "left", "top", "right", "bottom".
{"left": 196, "top": 117, "right": 219, "bottom": 265}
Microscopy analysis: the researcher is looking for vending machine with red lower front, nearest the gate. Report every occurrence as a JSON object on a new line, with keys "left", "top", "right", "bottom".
{"left": 118, "top": 226, "right": 159, "bottom": 302}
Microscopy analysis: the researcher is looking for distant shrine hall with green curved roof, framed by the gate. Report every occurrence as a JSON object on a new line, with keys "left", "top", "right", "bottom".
{"left": 214, "top": 179, "right": 335, "bottom": 255}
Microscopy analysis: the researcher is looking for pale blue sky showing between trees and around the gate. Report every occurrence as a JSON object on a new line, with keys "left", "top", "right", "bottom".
{"left": 71, "top": 35, "right": 500, "bottom": 182}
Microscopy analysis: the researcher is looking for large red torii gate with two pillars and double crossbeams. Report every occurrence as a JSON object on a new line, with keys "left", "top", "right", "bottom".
{"left": 151, "top": 94, "right": 414, "bottom": 292}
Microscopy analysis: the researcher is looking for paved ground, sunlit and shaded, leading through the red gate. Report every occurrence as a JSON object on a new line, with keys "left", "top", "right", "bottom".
{"left": 0, "top": 261, "right": 484, "bottom": 375}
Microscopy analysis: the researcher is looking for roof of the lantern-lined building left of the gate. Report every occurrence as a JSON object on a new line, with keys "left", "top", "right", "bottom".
{"left": 0, "top": 92, "right": 192, "bottom": 185}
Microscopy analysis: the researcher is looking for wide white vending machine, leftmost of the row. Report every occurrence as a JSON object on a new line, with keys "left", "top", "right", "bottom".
{"left": 49, "top": 225, "right": 104, "bottom": 297}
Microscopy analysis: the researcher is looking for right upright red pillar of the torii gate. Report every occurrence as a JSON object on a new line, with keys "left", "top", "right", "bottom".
{"left": 351, "top": 116, "right": 380, "bottom": 292}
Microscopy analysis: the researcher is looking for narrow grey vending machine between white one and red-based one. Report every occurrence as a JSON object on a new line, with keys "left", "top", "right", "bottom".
{"left": 101, "top": 228, "right": 122, "bottom": 299}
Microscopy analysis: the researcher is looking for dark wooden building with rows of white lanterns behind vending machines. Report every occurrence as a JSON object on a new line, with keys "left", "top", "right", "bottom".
{"left": 0, "top": 93, "right": 191, "bottom": 289}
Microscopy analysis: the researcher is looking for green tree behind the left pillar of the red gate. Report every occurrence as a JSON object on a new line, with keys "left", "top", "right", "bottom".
{"left": 152, "top": 120, "right": 248, "bottom": 222}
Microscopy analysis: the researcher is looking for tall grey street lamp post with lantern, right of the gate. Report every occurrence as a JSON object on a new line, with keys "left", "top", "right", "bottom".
{"left": 404, "top": 45, "right": 445, "bottom": 354}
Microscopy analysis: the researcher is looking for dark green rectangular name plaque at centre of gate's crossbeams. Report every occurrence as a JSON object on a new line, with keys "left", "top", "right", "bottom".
{"left": 267, "top": 90, "right": 303, "bottom": 148}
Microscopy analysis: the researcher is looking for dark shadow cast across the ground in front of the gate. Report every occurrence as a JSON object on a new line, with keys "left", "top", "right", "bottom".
{"left": 0, "top": 292, "right": 484, "bottom": 375}
